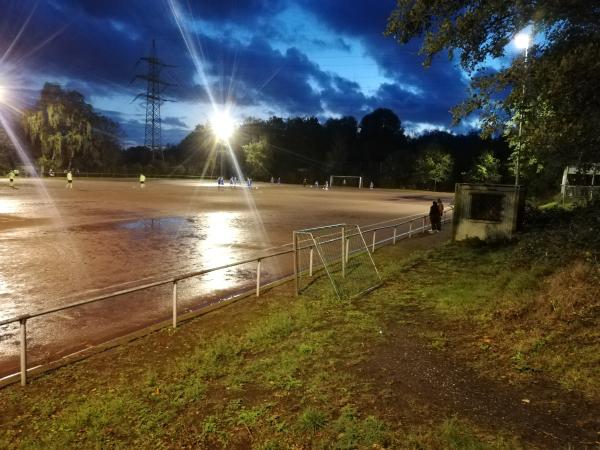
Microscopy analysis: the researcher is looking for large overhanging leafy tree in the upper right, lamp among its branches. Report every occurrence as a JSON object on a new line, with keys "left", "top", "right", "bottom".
{"left": 386, "top": 0, "right": 600, "bottom": 183}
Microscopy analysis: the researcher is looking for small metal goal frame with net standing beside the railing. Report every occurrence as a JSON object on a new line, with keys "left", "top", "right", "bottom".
{"left": 293, "top": 224, "right": 381, "bottom": 300}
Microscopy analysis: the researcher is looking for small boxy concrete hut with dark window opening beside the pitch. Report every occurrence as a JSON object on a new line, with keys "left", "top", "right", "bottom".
{"left": 452, "top": 183, "right": 525, "bottom": 241}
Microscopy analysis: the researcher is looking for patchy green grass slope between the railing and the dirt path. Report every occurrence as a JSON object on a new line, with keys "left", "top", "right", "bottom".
{"left": 0, "top": 206, "right": 600, "bottom": 449}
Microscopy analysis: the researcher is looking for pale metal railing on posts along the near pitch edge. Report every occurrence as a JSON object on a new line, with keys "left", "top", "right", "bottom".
{"left": 0, "top": 207, "right": 452, "bottom": 386}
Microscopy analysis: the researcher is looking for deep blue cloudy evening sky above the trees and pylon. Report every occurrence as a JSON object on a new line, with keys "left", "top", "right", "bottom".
{"left": 0, "top": 0, "right": 482, "bottom": 145}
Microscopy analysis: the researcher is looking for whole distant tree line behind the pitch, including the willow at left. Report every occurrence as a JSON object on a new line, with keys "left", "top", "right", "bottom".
{"left": 0, "top": 83, "right": 511, "bottom": 189}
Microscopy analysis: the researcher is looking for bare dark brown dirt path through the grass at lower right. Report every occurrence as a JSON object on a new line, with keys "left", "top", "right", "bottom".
{"left": 351, "top": 227, "right": 600, "bottom": 448}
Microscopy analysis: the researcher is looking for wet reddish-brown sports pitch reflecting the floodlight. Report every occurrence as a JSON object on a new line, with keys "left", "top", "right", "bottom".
{"left": 0, "top": 179, "right": 448, "bottom": 377}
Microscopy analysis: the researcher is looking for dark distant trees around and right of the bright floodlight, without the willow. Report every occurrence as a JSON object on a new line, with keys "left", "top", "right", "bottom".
{"left": 173, "top": 108, "right": 510, "bottom": 189}
